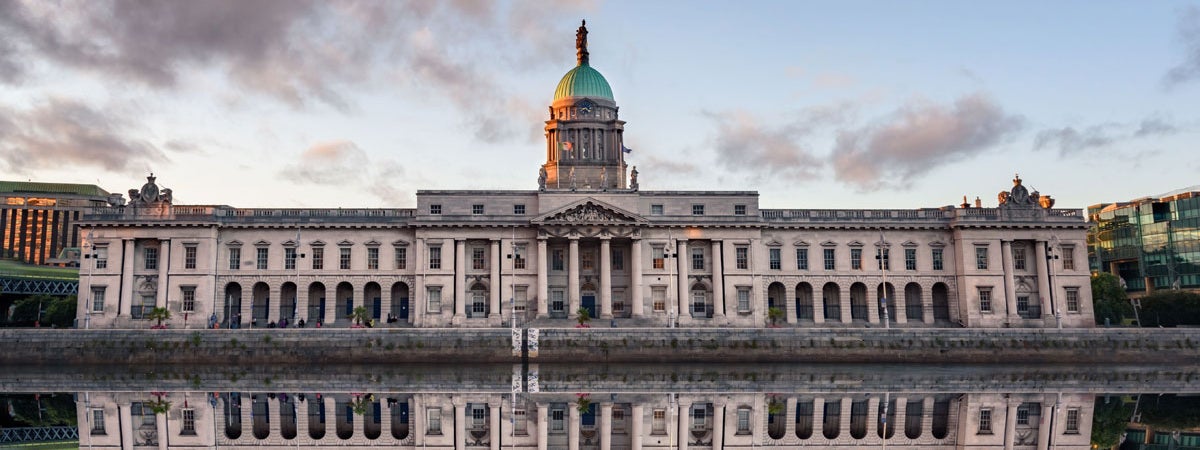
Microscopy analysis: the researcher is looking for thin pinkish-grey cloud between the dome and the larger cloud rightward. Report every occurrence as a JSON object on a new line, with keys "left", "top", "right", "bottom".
{"left": 706, "top": 103, "right": 853, "bottom": 179}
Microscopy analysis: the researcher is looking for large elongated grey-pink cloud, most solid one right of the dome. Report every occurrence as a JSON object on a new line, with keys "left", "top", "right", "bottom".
{"left": 830, "top": 94, "right": 1025, "bottom": 191}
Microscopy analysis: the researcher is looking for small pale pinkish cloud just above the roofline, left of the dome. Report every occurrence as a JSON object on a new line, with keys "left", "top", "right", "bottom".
{"left": 278, "top": 140, "right": 404, "bottom": 202}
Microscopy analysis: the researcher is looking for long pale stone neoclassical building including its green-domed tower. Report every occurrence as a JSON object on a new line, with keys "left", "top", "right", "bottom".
{"left": 70, "top": 21, "right": 1093, "bottom": 328}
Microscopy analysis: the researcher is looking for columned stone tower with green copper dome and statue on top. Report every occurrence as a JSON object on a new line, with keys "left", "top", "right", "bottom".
{"left": 540, "top": 22, "right": 629, "bottom": 190}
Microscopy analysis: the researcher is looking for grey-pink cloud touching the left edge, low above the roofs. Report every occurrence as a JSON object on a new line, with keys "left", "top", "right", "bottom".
{"left": 0, "top": 98, "right": 168, "bottom": 173}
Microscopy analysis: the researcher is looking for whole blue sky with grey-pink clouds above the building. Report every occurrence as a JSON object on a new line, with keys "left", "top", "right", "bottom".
{"left": 0, "top": 0, "right": 1200, "bottom": 209}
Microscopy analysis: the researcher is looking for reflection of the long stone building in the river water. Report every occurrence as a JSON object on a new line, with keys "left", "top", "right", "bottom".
{"left": 70, "top": 390, "right": 1096, "bottom": 450}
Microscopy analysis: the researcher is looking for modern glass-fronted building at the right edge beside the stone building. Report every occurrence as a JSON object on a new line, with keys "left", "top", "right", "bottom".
{"left": 1087, "top": 186, "right": 1200, "bottom": 294}
